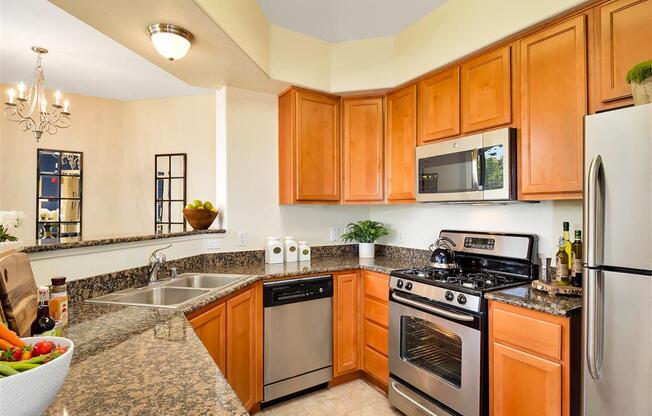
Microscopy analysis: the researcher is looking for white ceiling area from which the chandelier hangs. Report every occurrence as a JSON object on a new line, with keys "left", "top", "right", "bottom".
{"left": 0, "top": 0, "right": 209, "bottom": 100}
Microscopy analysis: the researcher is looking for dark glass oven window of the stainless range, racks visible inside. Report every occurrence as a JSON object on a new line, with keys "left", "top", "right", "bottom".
{"left": 401, "top": 316, "right": 462, "bottom": 388}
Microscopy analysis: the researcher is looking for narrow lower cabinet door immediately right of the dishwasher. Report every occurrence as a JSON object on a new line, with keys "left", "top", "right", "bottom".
{"left": 333, "top": 271, "right": 362, "bottom": 376}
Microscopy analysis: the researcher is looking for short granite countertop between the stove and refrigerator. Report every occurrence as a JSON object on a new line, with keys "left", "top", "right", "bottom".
{"left": 485, "top": 284, "right": 582, "bottom": 317}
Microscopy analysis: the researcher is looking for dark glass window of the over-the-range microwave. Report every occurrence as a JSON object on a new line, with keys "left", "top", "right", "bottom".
{"left": 419, "top": 151, "right": 477, "bottom": 194}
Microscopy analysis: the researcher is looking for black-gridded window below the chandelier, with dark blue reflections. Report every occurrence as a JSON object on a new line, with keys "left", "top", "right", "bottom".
{"left": 36, "top": 149, "right": 83, "bottom": 243}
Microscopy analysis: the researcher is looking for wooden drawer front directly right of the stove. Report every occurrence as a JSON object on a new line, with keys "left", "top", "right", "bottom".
{"left": 489, "top": 307, "right": 562, "bottom": 361}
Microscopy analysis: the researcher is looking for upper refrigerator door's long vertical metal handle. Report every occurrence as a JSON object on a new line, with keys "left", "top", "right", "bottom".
{"left": 584, "top": 155, "right": 604, "bottom": 267}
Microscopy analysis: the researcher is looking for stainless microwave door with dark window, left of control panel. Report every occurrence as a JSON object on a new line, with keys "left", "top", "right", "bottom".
{"left": 417, "top": 134, "right": 482, "bottom": 202}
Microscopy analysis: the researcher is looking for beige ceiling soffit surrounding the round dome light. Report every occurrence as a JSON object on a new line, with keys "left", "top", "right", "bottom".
{"left": 47, "top": 0, "right": 287, "bottom": 93}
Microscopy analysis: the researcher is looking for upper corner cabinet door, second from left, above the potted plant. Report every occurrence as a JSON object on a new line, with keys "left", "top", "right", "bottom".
{"left": 342, "top": 97, "right": 384, "bottom": 203}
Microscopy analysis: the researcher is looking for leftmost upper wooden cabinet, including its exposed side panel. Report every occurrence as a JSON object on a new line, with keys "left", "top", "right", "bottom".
{"left": 279, "top": 88, "right": 340, "bottom": 204}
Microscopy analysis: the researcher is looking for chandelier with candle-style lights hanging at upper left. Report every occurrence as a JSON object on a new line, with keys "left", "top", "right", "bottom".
{"left": 3, "top": 46, "right": 71, "bottom": 142}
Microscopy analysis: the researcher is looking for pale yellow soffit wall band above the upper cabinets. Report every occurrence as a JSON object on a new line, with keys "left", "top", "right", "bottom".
{"left": 196, "top": 0, "right": 585, "bottom": 92}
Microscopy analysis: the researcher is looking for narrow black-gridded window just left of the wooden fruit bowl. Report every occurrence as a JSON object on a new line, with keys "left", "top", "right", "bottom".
{"left": 154, "top": 153, "right": 187, "bottom": 234}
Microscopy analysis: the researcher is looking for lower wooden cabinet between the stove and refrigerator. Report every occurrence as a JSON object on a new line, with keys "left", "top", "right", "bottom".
{"left": 489, "top": 301, "right": 581, "bottom": 416}
